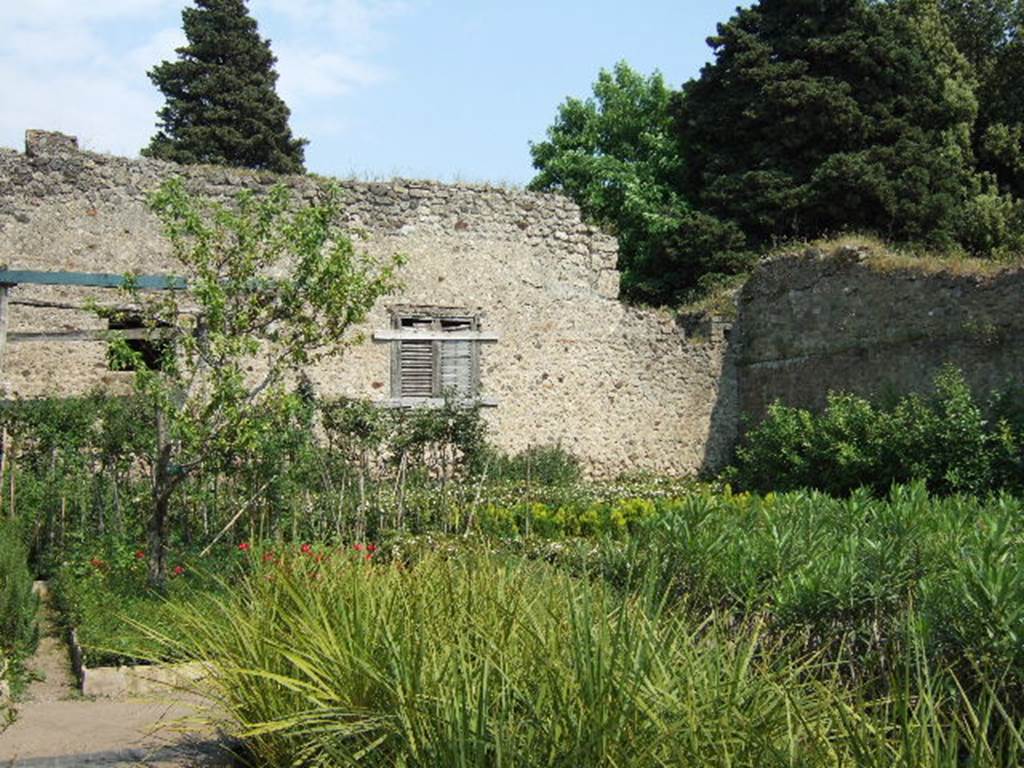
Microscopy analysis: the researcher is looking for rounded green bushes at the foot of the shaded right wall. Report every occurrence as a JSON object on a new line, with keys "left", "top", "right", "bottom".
{"left": 730, "top": 369, "right": 1024, "bottom": 495}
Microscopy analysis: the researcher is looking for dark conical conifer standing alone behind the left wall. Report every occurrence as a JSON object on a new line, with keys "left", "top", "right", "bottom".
{"left": 142, "top": 0, "right": 307, "bottom": 173}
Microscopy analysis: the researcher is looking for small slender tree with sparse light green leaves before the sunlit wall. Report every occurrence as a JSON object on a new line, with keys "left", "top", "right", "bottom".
{"left": 114, "top": 179, "right": 400, "bottom": 586}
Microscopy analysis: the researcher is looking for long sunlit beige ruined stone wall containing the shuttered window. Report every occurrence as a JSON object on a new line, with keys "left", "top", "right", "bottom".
{"left": 0, "top": 132, "right": 736, "bottom": 481}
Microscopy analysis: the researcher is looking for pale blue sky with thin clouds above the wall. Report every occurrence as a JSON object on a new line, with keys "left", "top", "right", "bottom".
{"left": 0, "top": 0, "right": 737, "bottom": 184}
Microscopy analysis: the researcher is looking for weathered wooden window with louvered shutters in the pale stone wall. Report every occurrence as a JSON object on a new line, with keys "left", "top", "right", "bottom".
{"left": 392, "top": 315, "right": 479, "bottom": 399}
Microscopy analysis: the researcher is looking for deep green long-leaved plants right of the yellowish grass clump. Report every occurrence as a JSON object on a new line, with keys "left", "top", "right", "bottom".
{"left": 622, "top": 483, "right": 1024, "bottom": 696}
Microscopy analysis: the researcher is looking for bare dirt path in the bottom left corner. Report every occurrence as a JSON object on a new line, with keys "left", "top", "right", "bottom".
{"left": 0, "top": 585, "right": 230, "bottom": 768}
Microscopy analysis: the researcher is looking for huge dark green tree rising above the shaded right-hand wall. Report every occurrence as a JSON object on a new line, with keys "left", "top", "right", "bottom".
{"left": 675, "top": 0, "right": 987, "bottom": 252}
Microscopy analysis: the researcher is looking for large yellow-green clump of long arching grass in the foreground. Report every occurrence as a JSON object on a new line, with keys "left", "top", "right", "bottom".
{"left": 144, "top": 553, "right": 864, "bottom": 768}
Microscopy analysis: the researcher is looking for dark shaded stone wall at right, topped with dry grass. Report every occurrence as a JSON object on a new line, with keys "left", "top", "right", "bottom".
{"left": 734, "top": 248, "right": 1024, "bottom": 422}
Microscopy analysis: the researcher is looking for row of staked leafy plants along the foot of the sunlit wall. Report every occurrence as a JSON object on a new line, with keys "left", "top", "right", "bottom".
{"left": 0, "top": 386, "right": 593, "bottom": 581}
